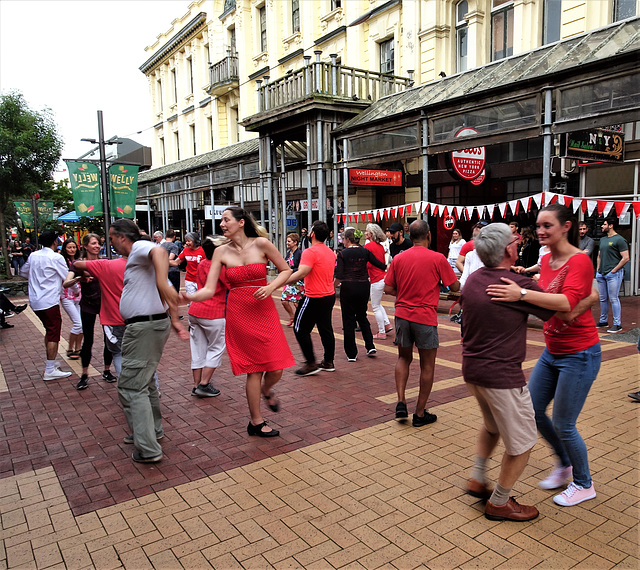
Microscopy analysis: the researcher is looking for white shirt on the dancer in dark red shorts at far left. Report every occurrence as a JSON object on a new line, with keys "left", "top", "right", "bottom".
{"left": 20, "top": 247, "right": 69, "bottom": 311}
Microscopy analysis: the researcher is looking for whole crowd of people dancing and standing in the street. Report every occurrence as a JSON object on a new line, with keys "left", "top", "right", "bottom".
{"left": 5, "top": 205, "right": 640, "bottom": 521}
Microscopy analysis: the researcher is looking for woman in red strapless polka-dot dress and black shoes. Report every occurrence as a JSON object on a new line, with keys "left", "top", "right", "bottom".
{"left": 183, "top": 208, "right": 295, "bottom": 437}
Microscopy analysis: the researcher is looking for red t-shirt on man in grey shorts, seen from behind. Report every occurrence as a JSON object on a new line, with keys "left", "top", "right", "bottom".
{"left": 384, "top": 245, "right": 457, "bottom": 326}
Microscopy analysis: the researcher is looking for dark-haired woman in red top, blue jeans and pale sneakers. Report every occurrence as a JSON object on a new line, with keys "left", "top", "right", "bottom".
{"left": 487, "top": 204, "right": 601, "bottom": 507}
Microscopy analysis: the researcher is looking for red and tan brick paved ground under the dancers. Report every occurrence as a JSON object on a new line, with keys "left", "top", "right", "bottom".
{"left": 0, "top": 290, "right": 640, "bottom": 569}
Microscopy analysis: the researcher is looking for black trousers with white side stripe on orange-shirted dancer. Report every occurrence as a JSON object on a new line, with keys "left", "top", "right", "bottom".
{"left": 293, "top": 294, "right": 336, "bottom": 364}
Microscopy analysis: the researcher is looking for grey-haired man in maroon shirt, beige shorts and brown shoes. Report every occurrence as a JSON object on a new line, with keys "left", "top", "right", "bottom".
{"left": 460, "top": 223, "right": 554, "bottom": 521}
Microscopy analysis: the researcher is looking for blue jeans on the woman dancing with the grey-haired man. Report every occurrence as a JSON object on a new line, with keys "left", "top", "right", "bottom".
{"left": 529, "top": 343, "right": 602, "bottom": 487}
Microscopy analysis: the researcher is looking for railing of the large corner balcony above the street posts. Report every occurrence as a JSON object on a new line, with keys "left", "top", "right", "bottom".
{"left": 256, "top": 51, "right": 413, "bottom": 113}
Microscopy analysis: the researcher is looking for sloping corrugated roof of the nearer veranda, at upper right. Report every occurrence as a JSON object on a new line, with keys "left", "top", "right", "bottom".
{"left": 335, "top": 17, "right": 640, "bottom": 132}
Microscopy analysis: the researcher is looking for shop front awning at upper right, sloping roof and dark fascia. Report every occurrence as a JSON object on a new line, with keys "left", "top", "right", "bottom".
{"left": 334, "top": 18, "right": 640, "bottom": 161}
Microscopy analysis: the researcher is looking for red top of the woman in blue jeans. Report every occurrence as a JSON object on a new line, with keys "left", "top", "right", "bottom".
{"left": 538, "top": 253, "right": 600, "bottom": 354}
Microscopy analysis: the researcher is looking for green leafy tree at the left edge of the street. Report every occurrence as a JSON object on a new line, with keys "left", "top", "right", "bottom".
{"left": 0, "top": 91, "right": 62, "bottom": 275}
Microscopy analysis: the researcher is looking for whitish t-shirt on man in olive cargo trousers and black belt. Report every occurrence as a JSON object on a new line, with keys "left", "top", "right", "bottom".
{"left": 120, "top": 240, "right": 167, "bottom": 320}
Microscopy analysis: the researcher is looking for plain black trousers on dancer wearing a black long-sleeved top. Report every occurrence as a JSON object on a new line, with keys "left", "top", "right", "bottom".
{"left": 340, "top": 281, "right": 375, "bottom": 358}
